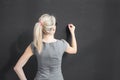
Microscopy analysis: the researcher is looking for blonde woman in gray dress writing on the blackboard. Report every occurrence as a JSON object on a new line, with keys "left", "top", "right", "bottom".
{"left": 14, "top": 14, "right": 77, "bottom": 80}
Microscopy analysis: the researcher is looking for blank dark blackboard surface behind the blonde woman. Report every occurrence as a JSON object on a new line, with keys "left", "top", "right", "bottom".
{"left": 0, "top": 0, "right": 120, "bottom": 80}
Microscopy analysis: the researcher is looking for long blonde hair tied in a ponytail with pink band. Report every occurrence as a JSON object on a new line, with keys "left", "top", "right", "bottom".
{"left": 33, "top": 14, "right": 56, "bottom": 53}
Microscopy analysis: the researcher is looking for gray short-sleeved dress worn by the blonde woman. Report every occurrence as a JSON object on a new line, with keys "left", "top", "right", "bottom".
{"left": 31, "top": 39, "right": 67, "bottom": 80}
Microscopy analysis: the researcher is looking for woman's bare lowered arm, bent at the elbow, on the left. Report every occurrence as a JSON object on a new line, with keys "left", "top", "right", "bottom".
{"left": 14, "top": 45, "right": 33, "bottom": 80}
